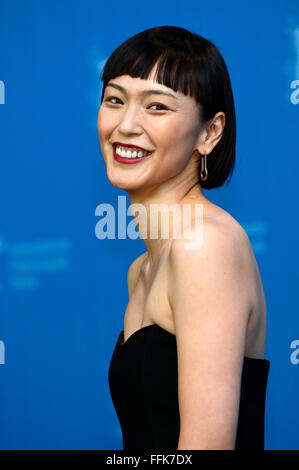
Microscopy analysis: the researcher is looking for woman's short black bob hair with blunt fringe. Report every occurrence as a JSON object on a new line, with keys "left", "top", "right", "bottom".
{"left": 101, "top": 26, "right": 236, "bottom": 189}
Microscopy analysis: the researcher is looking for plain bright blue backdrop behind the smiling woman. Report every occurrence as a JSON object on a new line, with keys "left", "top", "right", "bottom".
{"left": 0, "top": 0, "right": 299, "bottom": 449}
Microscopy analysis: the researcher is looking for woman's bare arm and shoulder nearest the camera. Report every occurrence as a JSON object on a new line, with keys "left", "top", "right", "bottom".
{"left": 169, "top": 224, "right": 250, "bottom": 449}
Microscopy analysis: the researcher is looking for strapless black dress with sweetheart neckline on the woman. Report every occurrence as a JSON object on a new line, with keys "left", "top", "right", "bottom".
{"left": 108, "top": 323, "right": 270, "bottom": 450}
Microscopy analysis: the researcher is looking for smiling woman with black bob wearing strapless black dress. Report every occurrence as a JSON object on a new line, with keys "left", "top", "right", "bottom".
{"left": 98, "top": 26, "right": 270, "bottom": 450}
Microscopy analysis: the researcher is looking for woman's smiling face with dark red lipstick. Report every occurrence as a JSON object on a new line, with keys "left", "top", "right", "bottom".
{"left": 98, "top": 63, "right": 204, "bottom": 191}
